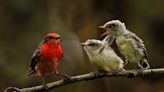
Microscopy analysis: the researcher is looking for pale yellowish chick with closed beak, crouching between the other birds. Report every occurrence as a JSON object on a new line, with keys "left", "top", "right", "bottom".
{"left": 82, "top": 37, "right": 124, "bottom": 73}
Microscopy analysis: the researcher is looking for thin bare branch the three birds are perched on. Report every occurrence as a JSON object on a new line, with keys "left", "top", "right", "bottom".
{"left": 4, "top": 68, "right": 164, "bottom": 92}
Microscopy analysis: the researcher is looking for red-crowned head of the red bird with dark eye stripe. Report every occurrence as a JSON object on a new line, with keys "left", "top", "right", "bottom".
{"left": 44, "top": 33, "right": 61, "bottom": 43}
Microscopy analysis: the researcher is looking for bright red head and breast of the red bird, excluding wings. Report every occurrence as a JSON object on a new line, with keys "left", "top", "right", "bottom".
{"left": 39, "top": 33, "right": 62, "bottom": 60}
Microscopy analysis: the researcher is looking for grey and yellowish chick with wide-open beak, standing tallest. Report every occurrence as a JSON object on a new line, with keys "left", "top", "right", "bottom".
{"left": 100, "top": 20, "right": 150, "bottom": 71}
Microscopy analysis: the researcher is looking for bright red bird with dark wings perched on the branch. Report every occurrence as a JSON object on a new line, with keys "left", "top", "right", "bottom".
{"left": 27, "top": 33, "right": 68, "bottom": 89}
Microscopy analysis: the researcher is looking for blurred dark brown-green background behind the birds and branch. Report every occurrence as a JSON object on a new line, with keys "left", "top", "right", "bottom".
{"left": 0, "top": 0, "right": 164, "bottom": 92}
